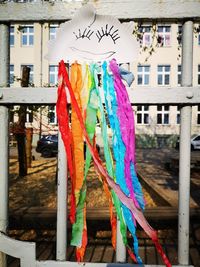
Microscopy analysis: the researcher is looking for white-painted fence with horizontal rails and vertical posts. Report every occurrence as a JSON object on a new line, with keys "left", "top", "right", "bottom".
{"left": 0, "top": 0, "right": 200, "bottom": 267}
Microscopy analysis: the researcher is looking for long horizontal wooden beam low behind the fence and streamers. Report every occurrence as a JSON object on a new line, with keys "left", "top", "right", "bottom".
{"left": 9, "top": 206, "right": 200, "bottom": 229}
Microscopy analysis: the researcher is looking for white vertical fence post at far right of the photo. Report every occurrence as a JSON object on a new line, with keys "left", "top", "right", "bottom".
{"left": 178, "top": 21, "right": 193, "bottom": 265}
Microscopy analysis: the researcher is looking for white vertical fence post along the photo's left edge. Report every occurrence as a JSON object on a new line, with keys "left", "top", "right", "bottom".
{"left": 0, "top": 24, "right": 9, "bottom": 267}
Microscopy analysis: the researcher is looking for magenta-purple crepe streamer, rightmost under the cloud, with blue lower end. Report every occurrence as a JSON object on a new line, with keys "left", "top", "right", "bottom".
{"left": 109, "top": 60, "right": 145, "bottom": 209}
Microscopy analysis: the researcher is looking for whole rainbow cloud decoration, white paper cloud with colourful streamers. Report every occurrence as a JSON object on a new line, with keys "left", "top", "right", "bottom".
{"left": 48, "top": 5, "right": 171, "bottom": 266}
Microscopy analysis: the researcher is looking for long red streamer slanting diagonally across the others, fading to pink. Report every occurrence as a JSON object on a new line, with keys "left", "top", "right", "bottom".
{"left": 58, "top": 61, "right": 171, "bottom": 267}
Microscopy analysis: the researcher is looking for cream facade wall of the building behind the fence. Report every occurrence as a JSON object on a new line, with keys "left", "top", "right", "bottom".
{"left": 10, "top": 22, "right": 200, "bottom": 149}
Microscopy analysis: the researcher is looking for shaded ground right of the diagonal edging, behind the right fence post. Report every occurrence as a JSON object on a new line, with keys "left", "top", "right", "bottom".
{"left": 137, "top": 149, "right": 200, "bottom": 207}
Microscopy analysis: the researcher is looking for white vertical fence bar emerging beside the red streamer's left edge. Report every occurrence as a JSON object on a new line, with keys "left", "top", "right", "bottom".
{"left": 56, "top": 132, "right": 67, "bottom": 261}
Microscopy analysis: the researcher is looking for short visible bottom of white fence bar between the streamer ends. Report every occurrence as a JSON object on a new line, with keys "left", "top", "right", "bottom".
{"left": 116, "top": 219, "right": 126, "bottom": 262}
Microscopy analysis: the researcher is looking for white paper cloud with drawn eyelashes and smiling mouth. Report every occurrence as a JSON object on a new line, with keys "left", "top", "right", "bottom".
{"left": 46, "top": 5, "right": 139, "bottom": 63}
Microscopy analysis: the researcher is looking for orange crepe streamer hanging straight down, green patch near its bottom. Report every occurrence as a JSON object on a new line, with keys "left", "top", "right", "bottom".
{"left": 70, "top": 63, "right": 87, "bottom": 261}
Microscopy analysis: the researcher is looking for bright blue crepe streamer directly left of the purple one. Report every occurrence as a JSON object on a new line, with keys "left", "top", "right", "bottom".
{"left": 102, "top": 62, "right": 142, "bottom": 263}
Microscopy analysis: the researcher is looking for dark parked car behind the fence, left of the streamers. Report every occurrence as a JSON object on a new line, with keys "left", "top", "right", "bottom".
{"left": 36, "top": 134, "right": 100, "bottom": 158}
